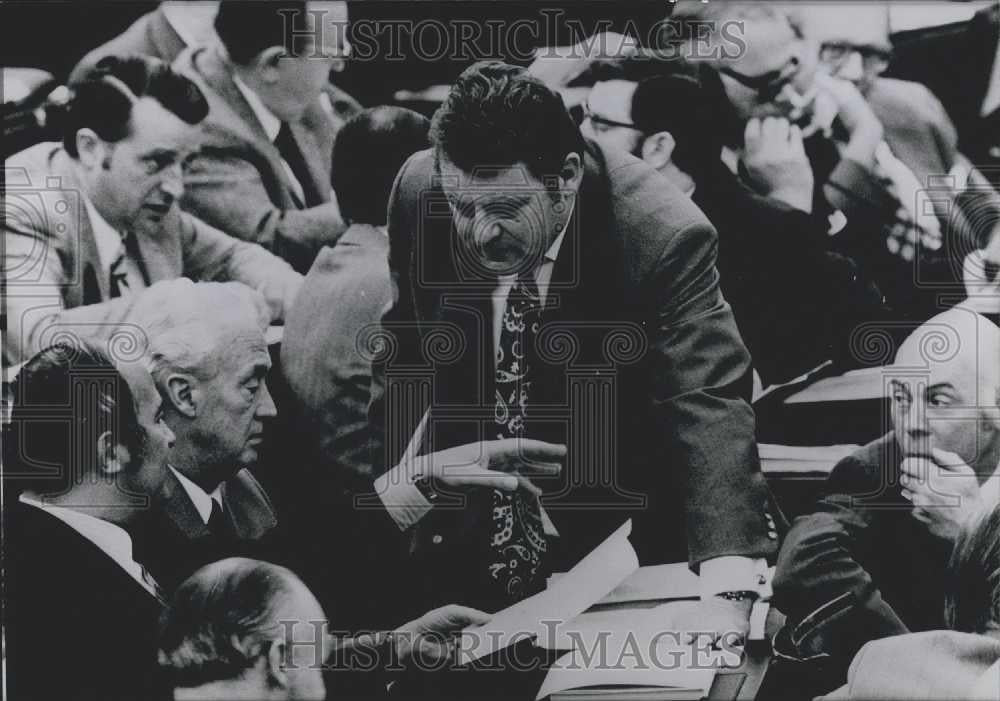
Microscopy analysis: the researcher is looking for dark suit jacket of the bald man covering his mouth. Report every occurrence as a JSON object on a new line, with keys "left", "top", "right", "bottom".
{"left": 773, "top": 433, "right": 951, "bottom": 664}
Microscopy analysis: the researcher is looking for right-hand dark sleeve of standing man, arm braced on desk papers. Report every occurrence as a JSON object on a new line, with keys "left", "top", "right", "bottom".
{"left": 646, "top": 219, "right": 776, "bottom": 569}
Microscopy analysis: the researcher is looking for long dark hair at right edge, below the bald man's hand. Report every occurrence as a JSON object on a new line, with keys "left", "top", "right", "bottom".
{"left": 944, "top": 505, "right": 1000, "bottom": 633}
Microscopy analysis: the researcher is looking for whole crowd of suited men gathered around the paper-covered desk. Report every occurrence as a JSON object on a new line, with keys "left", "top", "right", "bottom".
{"left": 2, "top": 1, "right": 1000, "bottom": 699}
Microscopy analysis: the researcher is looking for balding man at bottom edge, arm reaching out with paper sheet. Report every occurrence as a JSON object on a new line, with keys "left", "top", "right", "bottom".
{"left": 157, "top": 558, "right": 490, "bottom": 701}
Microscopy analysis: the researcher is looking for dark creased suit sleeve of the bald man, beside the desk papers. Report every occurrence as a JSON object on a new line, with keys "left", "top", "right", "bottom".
{"left": 772, "top": 457, "right": 908, "bottom": 659}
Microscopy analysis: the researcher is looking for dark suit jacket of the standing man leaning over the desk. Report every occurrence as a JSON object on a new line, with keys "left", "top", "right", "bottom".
{"left": 372, "top": 145, "right": 776, "bottom": 603}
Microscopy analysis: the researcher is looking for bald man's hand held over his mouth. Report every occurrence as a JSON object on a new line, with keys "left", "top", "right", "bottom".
{"left": 900, "top": 448, "right": 983, "bottom": 542}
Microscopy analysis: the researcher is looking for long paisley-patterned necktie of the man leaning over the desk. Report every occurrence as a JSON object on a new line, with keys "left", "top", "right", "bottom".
{"left": 489, "top": 274, "right": 548, "bottom": 603}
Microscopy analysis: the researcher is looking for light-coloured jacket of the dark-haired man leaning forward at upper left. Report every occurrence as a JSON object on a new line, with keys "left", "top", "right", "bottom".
{"left": 0, "top": 143, "right": 302, "bottom": 362}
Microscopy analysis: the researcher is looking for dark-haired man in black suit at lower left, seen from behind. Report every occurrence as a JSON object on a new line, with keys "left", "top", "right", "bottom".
{"left": 3, "top": 344, "right": 174, "bottom": 701}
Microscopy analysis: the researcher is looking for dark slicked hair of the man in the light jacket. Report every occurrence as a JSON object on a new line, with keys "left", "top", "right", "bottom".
{"left": 62, "top": 56, "right": 208, "bottom": 158}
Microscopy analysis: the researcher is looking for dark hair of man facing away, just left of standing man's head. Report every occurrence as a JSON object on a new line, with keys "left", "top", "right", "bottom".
{"left": 333, "top": 106, "right": 431, "bottom": 226}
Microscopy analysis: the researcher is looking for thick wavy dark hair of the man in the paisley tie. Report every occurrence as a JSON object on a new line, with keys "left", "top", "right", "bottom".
{"left": 431, "top": 61, "right": 585, "bottom": 180}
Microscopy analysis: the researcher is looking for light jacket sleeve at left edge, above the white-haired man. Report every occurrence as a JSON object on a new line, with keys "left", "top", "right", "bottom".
{"left": 2, "top": 205, "right": 130, "bottom": 363}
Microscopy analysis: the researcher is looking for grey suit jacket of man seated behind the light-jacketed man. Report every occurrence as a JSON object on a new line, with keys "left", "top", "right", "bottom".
{"left": 174, "top": 47, "right": 359, "bottom": 271}
